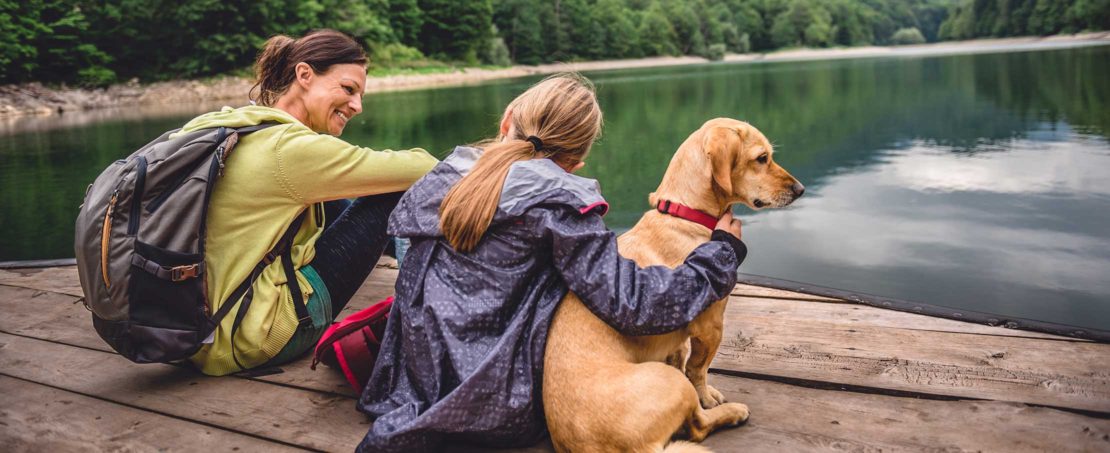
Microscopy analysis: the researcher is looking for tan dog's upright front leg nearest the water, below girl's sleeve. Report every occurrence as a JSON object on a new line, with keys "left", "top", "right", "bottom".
{"left": 686, "top": 300, "right": 727, "bottom": 409}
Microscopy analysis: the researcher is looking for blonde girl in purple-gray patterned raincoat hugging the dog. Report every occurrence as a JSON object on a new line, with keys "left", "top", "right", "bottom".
{"left": 359, "top": 74, "right": 746, "bottom": 452}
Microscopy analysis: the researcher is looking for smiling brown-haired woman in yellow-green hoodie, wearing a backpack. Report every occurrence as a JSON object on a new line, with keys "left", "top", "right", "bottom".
{"left": 180, "top": 30, "right": 437, "bottom": 375}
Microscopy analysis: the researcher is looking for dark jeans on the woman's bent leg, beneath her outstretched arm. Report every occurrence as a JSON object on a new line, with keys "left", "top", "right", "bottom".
{"left": 310, "top": 192, "right": 404, "bottom": 316}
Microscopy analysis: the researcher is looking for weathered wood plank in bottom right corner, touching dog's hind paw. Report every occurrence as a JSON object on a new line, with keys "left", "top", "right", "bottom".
{"left": 704, "top": 374, "right": 1110, "bottom": 452}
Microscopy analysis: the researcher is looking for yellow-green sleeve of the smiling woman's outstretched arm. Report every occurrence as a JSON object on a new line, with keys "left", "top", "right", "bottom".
{"left": 275, "top": 128, "right": 438, "bottom": 203}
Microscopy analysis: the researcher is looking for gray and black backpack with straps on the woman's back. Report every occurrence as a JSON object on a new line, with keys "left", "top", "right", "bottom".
{"left": 74, "top": 124, "right": 309, "bottom": 368}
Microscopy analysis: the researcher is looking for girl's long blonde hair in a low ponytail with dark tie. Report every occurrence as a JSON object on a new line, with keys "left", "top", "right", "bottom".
{"left": 440, "top": 74, "right": 602, "bottom": 252}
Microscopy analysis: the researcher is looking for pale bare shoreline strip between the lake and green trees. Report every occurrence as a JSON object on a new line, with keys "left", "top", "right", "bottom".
{"left": 0, "top": 31, "right": 1110, "bottom": 125}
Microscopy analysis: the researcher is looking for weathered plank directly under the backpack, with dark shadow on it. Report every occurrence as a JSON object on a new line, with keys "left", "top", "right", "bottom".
{"left": 0, "top": 333, "right": 370, "bottom": 451}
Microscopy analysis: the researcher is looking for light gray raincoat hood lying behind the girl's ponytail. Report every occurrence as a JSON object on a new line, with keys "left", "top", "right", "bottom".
{"left": 389, "top": 147, "right": 609, "bottom": 238}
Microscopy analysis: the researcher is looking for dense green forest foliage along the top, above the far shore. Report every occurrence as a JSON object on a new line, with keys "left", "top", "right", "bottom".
{"left": 0, "top": 0, "right": 1110, "bottom": 85}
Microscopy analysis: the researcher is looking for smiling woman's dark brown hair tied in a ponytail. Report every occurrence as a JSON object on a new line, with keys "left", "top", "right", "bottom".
{"left": 248, "top": 29, "right": 369, "bottom": 107}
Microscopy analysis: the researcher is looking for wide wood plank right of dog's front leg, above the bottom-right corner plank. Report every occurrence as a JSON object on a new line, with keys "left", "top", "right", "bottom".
{"left": 713, "top": 312, "right": 1110, "bottom": 412}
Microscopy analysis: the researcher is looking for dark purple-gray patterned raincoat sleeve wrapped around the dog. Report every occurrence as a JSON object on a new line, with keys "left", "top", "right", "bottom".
{"left": 546, "top": 209, "right": 744, "bottom": 335}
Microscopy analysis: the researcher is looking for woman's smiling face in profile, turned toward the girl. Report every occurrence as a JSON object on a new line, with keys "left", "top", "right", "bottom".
{"left": 296, "top": 63, "right": 366, "bottom": 137}
